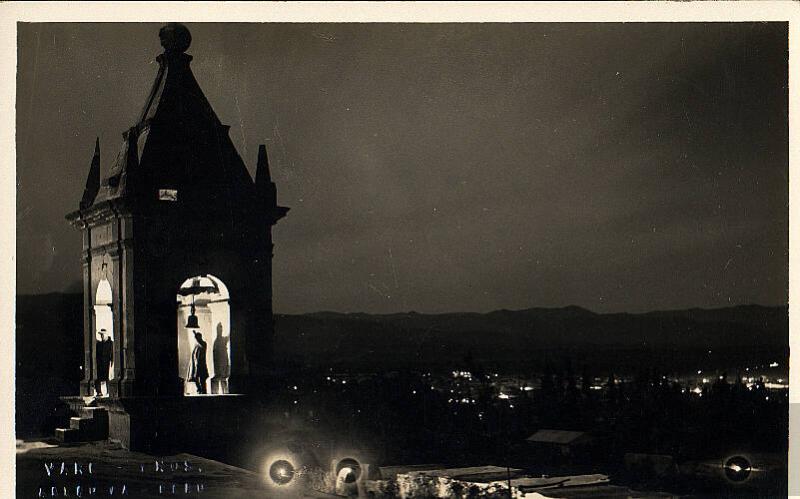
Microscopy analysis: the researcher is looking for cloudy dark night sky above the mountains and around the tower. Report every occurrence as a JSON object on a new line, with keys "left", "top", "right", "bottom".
{"left": 17, "top": 23, "right": 789, "bottom": 312}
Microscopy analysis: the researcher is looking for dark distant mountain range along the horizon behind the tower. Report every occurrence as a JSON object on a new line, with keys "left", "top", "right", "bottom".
{"left": 16, "top": 293, "right": 789, "bottom": 380}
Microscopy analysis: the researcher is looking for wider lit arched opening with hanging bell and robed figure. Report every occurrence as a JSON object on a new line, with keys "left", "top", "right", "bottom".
{"left": 177, "top": 274, "right": 231, "bottom": 395}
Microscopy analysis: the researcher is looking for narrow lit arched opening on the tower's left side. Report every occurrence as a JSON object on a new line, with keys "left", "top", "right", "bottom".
{"left": 94, "top": 278, "right": 114, "bottom": 397}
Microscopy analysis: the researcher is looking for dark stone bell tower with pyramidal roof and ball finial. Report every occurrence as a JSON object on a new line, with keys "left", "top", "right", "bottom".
{"left": 66, "top": 24, "right": 289, "bottom": 406}
